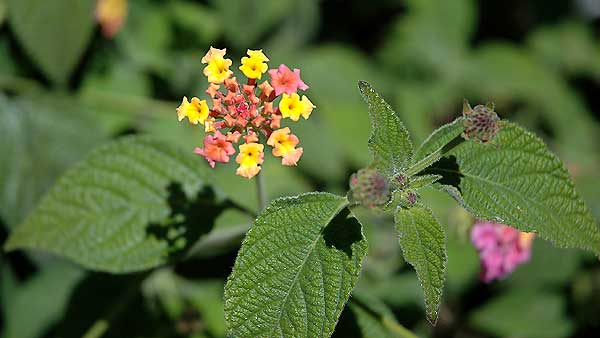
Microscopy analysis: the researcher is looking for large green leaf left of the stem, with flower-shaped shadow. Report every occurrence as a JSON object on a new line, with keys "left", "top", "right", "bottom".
{"left": 6, "top": 136, "right": 225, "bottom": 273}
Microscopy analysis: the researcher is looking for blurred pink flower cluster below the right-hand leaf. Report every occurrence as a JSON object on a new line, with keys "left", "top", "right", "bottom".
{"left": 471, "top": 221, "right": 534, "bottom": 283}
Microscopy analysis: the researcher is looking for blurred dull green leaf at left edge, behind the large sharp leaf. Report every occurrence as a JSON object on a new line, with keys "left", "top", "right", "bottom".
{"left": 0, "top": 95, "right": 105, "bottom": 229}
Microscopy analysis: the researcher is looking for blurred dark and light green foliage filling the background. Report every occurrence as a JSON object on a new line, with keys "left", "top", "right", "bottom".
{"left": 0, "top": 0, "right": 600, "bottom": 338}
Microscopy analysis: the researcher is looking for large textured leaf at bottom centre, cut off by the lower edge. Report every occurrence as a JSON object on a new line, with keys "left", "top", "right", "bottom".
{"left": 225, "top": 193, "right": 367, "bottom": 338}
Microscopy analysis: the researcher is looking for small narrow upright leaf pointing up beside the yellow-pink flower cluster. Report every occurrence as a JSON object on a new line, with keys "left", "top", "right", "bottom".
{"left": 358, "top": 81, "right": 413, "bottom": 177}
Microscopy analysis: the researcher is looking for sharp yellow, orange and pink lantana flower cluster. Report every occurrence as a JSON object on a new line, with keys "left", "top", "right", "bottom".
{"left": 177, "top": 47, "right": 315, "bottom": 178}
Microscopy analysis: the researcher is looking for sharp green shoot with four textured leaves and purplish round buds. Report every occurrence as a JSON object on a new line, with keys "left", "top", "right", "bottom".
{"left": 225, "top": 82, "right": 600, "bottom": 338}
